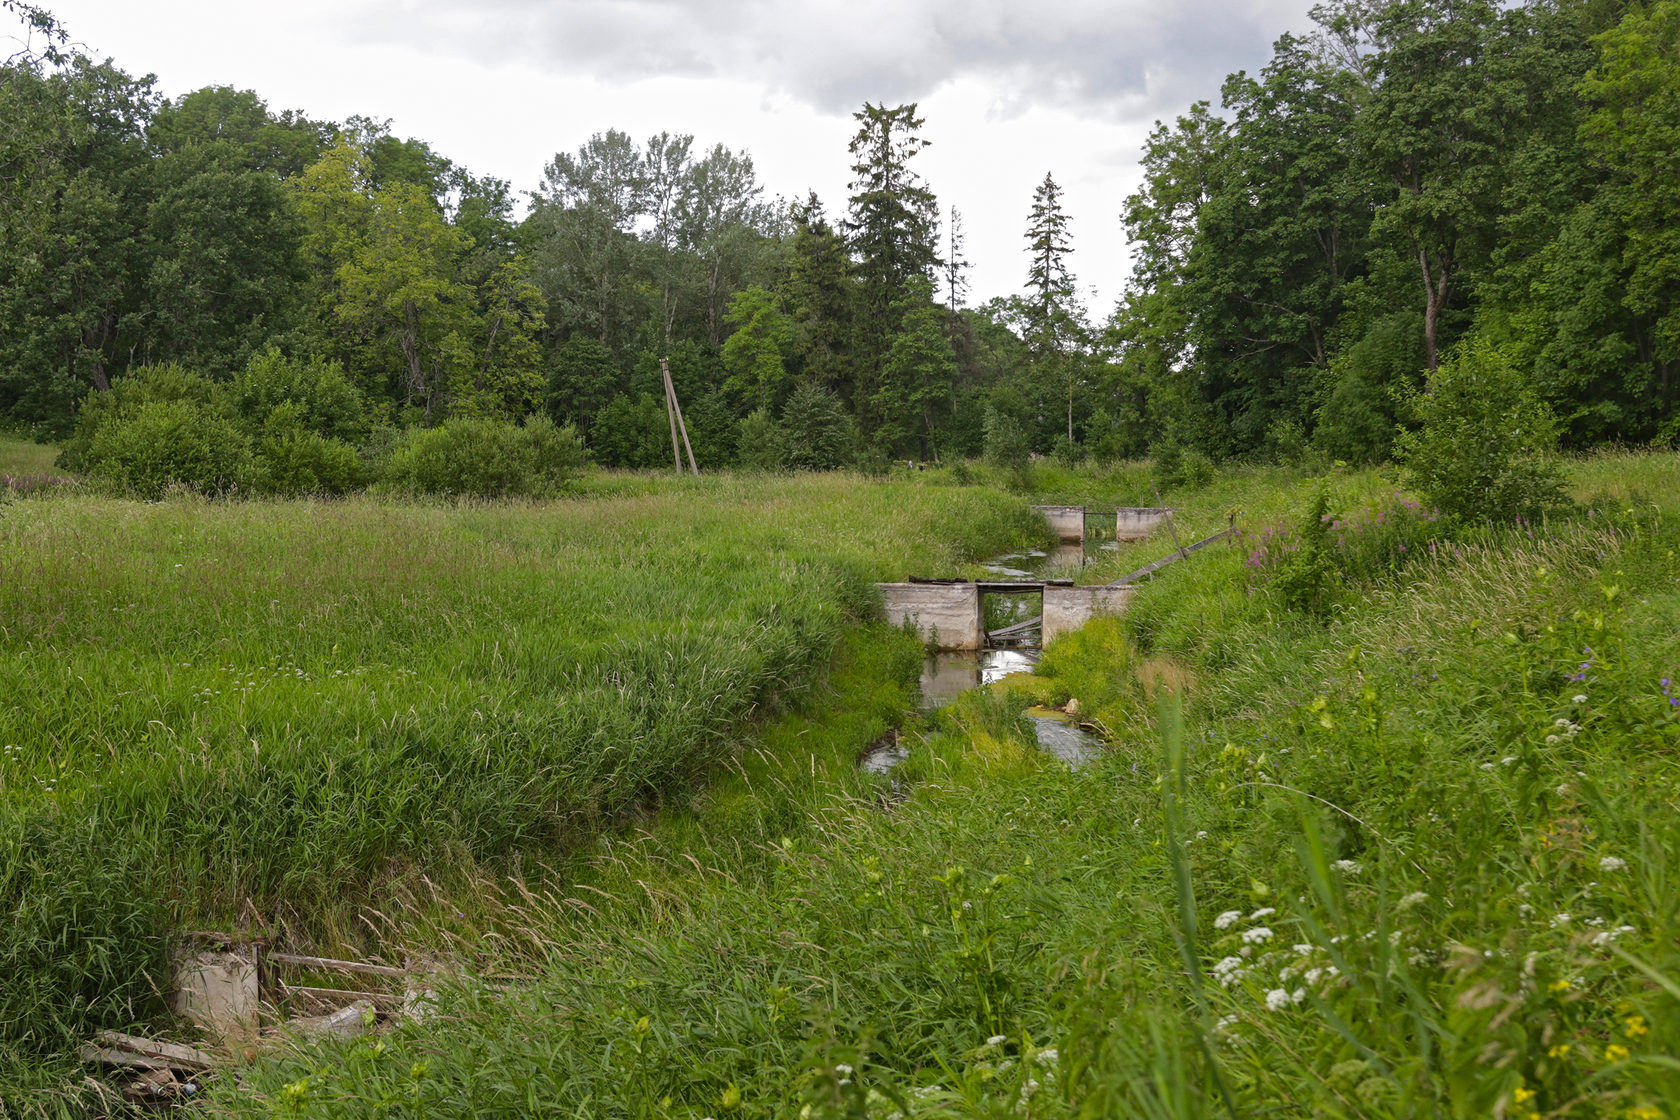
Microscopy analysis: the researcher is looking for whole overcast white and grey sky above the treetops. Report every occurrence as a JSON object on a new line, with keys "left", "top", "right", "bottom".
{"left": 29, "top": 0, "right": 1309, "bottom": 317}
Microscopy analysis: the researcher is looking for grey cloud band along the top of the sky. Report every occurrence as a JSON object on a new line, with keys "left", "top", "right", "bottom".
{"left": 351, "top": 0, "right": 1304, "bottom": 121}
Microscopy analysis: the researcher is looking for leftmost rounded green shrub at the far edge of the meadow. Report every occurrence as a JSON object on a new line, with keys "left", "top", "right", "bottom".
{"left": 81, "top": 400, "right": 257, "bottom": 499}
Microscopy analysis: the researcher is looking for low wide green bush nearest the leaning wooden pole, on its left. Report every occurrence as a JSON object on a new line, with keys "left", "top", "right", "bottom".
{"left": 381, "top": 416, "right": 585, "bottom": 497}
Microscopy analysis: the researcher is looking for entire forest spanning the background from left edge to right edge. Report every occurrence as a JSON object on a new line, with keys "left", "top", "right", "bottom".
{"left": 0, "top": 0, "right": 1680, "bottom": 490}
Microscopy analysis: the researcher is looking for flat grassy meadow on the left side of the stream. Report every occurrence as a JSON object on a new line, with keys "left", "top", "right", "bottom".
{"left": 0, "top": 475, "right": 1043, "bottom": 1093}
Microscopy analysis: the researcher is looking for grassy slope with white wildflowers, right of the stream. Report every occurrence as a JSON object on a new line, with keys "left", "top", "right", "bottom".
{"left": 218, "top": 457, "right": 1680, "bottom": 1120}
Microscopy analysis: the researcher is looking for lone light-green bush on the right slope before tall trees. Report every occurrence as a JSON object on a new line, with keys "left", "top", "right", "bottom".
{"left": 1396, "top": 339, "right": 1567, "bottom": 521}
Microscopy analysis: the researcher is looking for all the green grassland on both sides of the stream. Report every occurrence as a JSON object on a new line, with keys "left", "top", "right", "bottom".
{"left": 0, "top": 443, "right": 1680, "bottom": 1120}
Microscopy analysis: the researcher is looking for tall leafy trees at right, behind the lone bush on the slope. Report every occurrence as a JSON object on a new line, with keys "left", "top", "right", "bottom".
{"left": 1109, "top": 0, "right": 1680, "bottom": 460}
